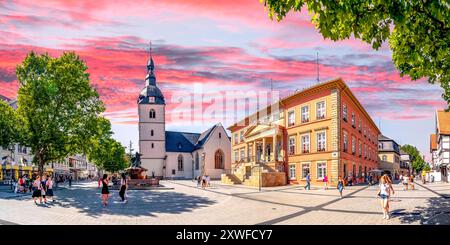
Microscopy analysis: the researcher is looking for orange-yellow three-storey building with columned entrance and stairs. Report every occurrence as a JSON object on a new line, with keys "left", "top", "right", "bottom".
{"left": 222, "top": 78, "right": 380, "bottom": 186}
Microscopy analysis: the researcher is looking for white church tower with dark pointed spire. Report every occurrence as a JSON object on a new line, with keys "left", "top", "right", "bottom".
{"left": 137, "top": 46, "right": 166, "bottom": 177}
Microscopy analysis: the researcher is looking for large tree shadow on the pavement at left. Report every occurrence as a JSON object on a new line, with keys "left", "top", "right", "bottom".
{"left": 0, "top": 186, "right": 215, "bottom": 217}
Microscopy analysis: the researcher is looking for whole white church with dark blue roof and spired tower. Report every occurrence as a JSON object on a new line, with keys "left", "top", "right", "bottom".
{"left": 137, "top": 47, "right": 231, "bottom": 179}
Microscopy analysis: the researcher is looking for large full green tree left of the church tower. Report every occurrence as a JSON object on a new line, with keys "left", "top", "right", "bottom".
{"left": 16, "top": 52, "right": 105, "bottom": 175}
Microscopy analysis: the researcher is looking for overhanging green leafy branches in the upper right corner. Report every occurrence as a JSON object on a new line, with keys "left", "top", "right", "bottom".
{"left": 260, "top": 0, "right": 450, "bottom": 109}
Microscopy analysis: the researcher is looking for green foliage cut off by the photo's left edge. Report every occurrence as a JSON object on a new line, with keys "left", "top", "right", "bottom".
{"left": 0, "top": 101, "right": 20, "bottom": 149}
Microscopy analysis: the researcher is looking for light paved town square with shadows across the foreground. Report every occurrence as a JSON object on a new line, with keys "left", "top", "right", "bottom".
{"left": 0, "top": 180, "right": 450, "bottom": 225}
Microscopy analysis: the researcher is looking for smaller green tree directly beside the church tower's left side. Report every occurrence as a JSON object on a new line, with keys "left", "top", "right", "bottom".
{"left": 87, "top": 118, "right": 127, "bottom": 172}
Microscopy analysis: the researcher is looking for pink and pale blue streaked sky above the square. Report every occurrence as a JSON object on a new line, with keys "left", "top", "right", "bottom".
{"left": 0, "top": 0, "right": 445, "bottom": 159}
